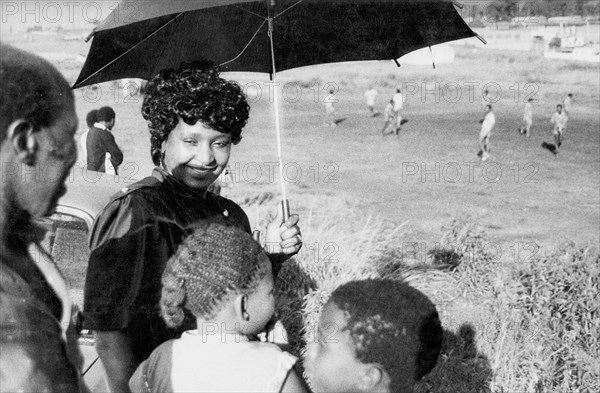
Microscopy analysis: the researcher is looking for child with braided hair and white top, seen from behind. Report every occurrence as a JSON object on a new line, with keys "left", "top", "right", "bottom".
{"left": 129, "top": 223, "right": 305, "bottom": 393}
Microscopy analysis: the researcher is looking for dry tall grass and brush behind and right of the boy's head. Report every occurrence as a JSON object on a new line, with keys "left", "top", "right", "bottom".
{"left": 237, "top": 185, "right": 600, "bottom": 393}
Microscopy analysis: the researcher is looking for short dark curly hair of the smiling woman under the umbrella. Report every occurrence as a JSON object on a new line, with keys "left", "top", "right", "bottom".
{"left": 142, "top": 61, "right": 250, "bottom": 165}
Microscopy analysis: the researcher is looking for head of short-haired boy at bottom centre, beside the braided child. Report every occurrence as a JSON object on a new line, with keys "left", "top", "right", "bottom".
{"left": 305, "top": 279, "right": 443, "bottom": 393}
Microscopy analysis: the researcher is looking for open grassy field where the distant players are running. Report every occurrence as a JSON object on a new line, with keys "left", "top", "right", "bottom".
{"left": 3, "top": 31, "right": 600, "bottom": 393}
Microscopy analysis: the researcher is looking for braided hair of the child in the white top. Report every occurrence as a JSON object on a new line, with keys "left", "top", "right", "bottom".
{"left": 160, "top": 222, "right": 270, "bottom": 327}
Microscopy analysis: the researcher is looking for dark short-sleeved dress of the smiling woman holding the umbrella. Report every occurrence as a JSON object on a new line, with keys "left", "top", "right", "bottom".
{"left": 83, "top": 168, "right": 251, "bottom": 362}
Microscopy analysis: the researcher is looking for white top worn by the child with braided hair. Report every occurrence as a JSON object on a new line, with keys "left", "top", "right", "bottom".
{"left": 130, "top": 330, "right": 297, "bottom": 393}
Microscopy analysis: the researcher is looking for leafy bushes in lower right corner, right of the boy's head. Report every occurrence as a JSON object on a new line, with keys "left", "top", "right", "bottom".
{"left": 428, "top": 216, "right": 600, "bottom": 393}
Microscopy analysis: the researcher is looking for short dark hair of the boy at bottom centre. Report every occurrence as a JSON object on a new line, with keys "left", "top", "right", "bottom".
{"left": 330, "top": 279, "right": 443, "bottom": 392}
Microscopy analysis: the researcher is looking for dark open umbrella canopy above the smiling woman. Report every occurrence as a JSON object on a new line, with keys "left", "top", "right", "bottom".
{"left": 74, "top": 0, "right": 476, "bottom": 88}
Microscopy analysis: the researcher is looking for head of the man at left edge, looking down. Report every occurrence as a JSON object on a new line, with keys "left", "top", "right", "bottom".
{"left": 0, "top": 43, "right": 77, "bottom": 218}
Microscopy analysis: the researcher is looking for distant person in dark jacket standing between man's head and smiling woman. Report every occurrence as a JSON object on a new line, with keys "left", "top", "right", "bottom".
{"left": 86, "top": 106, "right": 123, "bottom": 174}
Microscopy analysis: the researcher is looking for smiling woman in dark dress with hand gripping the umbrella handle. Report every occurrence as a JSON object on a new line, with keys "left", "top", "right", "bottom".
{"left": 83, "top": 62, "right": 302, "bottom": 392}
